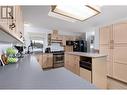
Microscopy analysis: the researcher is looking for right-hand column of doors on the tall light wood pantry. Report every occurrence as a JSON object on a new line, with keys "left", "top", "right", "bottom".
{"left": 113, "top": 22, "right": 127, "bottom": 82}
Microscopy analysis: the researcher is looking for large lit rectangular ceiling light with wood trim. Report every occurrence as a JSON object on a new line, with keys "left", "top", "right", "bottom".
{"left": 51, "top": 5, "right": 100, "bottom": 22}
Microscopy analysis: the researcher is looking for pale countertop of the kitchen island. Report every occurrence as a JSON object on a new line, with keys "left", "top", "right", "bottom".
{"left": 65, "top": 52, "right": 107, "bottom": 58}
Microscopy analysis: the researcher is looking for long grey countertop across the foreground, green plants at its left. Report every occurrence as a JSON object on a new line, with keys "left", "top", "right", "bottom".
{"left": 0, "top": 55, "right": 96, "bottom": 89}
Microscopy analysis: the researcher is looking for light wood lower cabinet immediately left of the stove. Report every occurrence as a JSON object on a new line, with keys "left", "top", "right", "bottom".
{"left": 35, "top": 53, "right": 53, "bottom": 69}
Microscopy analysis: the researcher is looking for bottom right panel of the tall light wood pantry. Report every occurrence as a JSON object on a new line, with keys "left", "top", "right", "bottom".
{"left": 113, "top": 63, "right": 127, "bottom": 82}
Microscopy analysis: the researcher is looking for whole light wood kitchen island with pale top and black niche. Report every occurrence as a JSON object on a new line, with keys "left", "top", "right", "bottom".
{"left": 65, "top": 52, "right": 107, "bottom": 89}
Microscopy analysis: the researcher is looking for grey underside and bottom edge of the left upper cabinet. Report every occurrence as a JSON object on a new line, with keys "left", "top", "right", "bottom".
{"left": 0, "top": 26, "right": 23, "bottom": 44}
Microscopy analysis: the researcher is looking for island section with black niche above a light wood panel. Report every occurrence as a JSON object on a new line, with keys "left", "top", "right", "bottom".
{"left": 80, "top": 60, "right": 92, "bottom": 83}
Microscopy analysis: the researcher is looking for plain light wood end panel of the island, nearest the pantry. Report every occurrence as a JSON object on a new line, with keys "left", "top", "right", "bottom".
{"left": 92, "top": 57, "right": 107, "bottom": 88}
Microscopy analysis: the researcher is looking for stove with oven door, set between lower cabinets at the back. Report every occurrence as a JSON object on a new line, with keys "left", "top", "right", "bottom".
{"left": 52, "top": 51, "right": 64, "bottom": 68}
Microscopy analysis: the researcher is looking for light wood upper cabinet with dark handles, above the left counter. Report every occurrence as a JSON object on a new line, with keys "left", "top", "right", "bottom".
{"left": 0, "top": 6, "right": 24, "bottom": 43}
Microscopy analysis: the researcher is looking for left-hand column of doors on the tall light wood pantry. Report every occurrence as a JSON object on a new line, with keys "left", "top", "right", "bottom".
{"left": 99, "top": 25, "right": 113, "bottom": 76}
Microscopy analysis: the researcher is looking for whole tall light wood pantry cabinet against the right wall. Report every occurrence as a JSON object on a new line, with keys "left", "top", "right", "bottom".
{"left": 100, "top": 22, "right": 127, "bottom": 82}
